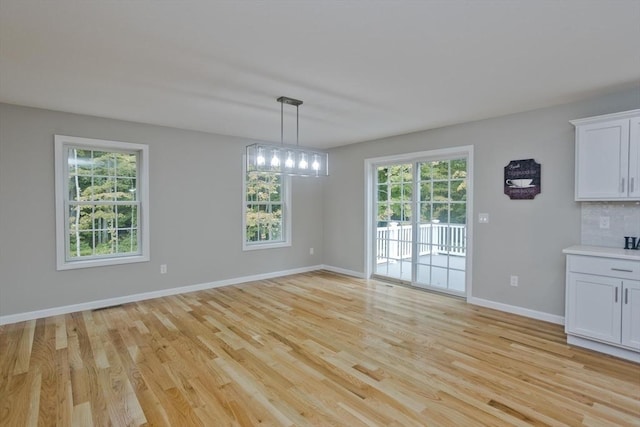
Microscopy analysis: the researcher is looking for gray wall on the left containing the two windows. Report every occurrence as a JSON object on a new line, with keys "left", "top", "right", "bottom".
{"left": 0, "top": 104, "right": 325, "bottom": 316}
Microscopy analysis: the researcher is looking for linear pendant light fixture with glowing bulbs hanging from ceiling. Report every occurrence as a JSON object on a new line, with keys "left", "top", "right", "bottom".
{"left": 247, "top": 96, "right": 329, "bottom": 177}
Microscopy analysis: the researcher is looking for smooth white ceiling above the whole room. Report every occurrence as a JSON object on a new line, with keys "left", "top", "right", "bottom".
{"left": 0, "top": 0, "right": 640, "bottom": 147}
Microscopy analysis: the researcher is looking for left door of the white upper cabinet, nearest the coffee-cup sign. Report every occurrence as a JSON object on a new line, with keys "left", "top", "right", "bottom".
{"left": 576, "top": 119, "right": 629, "bottom": 200}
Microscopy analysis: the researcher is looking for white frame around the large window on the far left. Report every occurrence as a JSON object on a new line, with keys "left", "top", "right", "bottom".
{"left": 54, "top": 135, "right": 150, "bottom": 270}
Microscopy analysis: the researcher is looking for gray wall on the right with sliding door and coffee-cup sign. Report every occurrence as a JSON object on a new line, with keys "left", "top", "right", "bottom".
{"left": 324, "top": 88, "right": 640, "bottom": 316}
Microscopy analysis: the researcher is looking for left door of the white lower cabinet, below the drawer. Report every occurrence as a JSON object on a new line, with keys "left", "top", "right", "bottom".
{"left": 566, "top": 273, "right": 622, "bottom": 344}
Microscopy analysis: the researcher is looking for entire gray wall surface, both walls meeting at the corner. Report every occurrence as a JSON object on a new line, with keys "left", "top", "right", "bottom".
{"left": 0, "top": 89, "right": 640, "bottom": 316}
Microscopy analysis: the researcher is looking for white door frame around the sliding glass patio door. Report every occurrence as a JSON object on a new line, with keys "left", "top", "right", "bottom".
{"left": 364, "top": 145, "right": 474, "bottom": 300}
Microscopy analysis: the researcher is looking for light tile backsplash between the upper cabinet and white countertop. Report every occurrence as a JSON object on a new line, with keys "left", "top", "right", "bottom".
{"left": 580, "top": 202, "right": 640, "bottom": 248}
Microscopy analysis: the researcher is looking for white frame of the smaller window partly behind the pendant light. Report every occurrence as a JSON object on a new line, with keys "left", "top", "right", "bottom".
{"left": 242, "top": 155, "right": 291, "bottom": 251}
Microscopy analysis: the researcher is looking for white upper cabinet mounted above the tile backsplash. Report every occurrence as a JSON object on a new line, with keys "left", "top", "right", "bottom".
{"left": 571, "top": 110, "right": 640, "bottom": 200}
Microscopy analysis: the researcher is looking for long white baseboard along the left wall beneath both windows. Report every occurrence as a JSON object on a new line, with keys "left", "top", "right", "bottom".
{"left": 0, "top": 265, "right": 322, "bottom": 325}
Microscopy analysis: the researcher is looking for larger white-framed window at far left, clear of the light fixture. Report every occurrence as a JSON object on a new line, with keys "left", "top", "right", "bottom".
{"left": 55, "top": 135, "right": 149, "bottom": 270}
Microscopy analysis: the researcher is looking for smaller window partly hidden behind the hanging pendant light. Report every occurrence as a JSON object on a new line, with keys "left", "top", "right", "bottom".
{"left": 243, "top": 162, "right": 291, "bottom": 250}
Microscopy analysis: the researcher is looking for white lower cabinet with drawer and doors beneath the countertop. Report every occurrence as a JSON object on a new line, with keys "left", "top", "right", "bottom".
{"left": 565, "top": 255, "right": 640, "bottom": 361}
